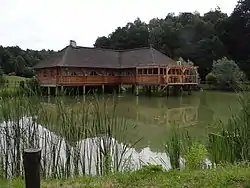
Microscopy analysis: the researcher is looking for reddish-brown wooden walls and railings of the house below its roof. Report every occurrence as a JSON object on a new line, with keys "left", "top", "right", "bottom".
{"left": 36, "top": 68, "right": 197, "bottom": 86}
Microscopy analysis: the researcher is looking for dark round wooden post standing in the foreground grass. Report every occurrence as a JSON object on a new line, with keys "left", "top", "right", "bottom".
{"left": 23, "top": 149, "right": 41, "bottom": 188}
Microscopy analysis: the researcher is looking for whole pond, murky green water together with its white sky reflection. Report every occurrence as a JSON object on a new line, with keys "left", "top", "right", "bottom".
{"left": 0, "top": 91, "right": 240, "bottom": 178}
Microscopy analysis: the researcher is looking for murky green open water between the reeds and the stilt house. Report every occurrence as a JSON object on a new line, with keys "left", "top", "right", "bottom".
{"left": 43, "top": 91, "right": 240, "bottom": 152}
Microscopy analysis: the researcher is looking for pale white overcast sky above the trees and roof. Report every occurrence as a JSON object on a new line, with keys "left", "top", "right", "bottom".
{"left": 0, "top": 0, "right": 237, "bottom": 50}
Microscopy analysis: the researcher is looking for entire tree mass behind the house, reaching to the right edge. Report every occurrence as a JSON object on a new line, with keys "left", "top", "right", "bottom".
{"left": 94, "top": 0, "right": 250, "bottom": 80}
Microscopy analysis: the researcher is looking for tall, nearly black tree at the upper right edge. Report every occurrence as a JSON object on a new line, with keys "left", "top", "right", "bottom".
{"left": 220, "top": 0, "right": 250, "bottom": 78}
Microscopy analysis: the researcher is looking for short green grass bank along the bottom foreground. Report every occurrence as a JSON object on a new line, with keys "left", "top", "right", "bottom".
{"left": 0, "top": 165, "right": 250, "bottom": 188}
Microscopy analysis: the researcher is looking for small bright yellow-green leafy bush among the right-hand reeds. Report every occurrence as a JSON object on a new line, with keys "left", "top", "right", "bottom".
{"left": 184, "top": 142, "right": 208, "bottom": 169}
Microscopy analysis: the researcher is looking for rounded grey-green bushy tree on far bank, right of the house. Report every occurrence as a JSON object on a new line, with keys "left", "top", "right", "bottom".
{"left": 210, "top": 57, "right": 246, "bottom": 89}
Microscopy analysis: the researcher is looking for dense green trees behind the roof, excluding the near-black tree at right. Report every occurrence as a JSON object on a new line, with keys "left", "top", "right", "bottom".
{"left": 95, "top": 8, "right": 230, "bottom": 80}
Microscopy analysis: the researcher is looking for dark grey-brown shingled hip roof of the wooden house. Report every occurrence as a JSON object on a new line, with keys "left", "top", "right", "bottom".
{"left": 34, "top": 46, "right": 176, "bottom": 69}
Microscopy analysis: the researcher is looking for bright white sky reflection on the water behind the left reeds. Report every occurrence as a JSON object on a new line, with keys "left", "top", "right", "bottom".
{"left": 0, "top": 117, "right": 171, "bottom": 178}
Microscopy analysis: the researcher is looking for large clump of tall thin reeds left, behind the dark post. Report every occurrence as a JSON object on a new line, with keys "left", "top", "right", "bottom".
{"left": 0, "top": 93, "right": 139, "bottom": 178}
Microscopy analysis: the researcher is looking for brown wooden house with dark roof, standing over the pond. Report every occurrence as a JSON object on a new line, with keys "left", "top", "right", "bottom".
{"left": 34, "top": 41, "right": 198, "bottom": 92}
